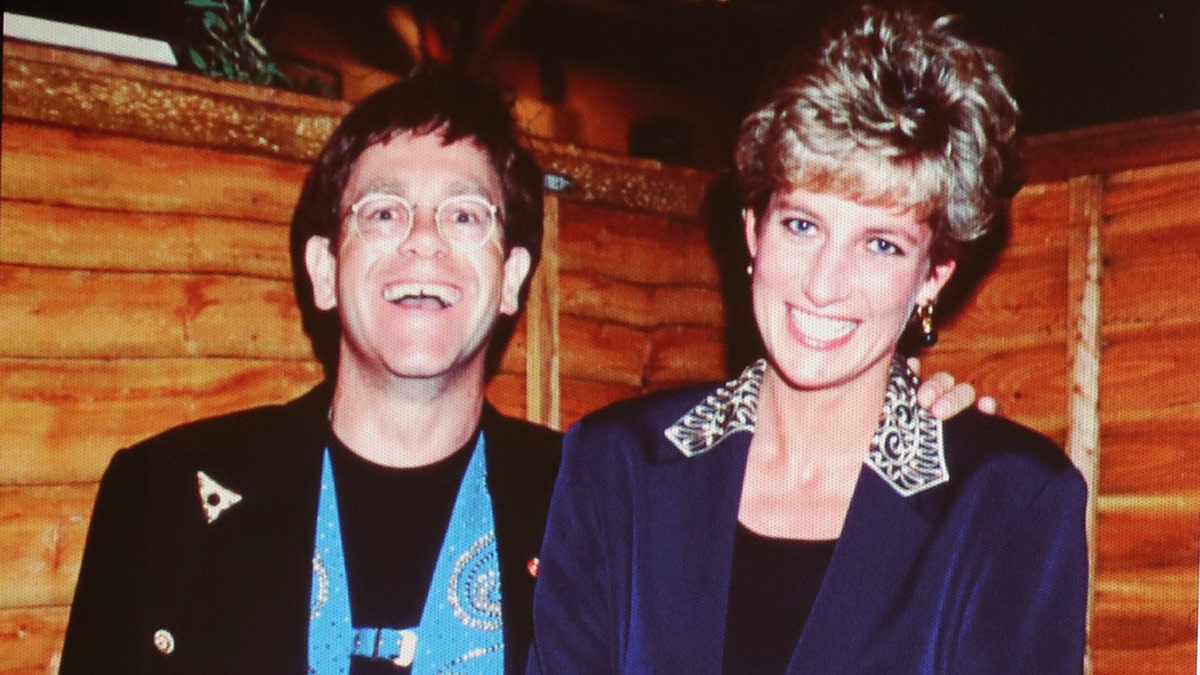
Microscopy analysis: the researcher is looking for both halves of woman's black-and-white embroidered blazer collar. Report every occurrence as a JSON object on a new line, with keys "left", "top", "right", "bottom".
{"left": 664, "top": 357, "right": 950, "bottom": 497}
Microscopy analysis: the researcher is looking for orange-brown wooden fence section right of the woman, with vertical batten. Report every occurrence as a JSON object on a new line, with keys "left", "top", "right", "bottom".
{"left": 925, "top": 113, "right": 1200, "bottom": 675}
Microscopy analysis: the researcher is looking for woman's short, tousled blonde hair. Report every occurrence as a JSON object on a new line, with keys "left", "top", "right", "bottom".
{"left": 736, "top": 5, "right": 1020, "bottom": 259}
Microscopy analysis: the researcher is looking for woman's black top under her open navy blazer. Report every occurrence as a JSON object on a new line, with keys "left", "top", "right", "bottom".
{"left": 725, "top": 522, "right": 838, "bottom": 675}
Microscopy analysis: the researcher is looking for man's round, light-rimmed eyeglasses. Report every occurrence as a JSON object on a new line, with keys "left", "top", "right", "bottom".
{"left": 347, "top": 192, "right": 497, "bottom": 250}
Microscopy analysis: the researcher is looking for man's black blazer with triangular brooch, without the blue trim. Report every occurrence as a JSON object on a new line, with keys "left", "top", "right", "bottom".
{"left": 60, "top": 384, "right": 562, "bottom": 675}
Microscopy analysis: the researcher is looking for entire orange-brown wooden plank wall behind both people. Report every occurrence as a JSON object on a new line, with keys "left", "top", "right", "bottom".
{"left": 0, "top": 42, "right": 1200, "bottom": 674}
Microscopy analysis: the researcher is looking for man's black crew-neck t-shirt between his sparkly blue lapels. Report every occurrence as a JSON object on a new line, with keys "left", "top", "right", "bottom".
{"left": 329, "top": 434, "right": 478, "bottom": 675}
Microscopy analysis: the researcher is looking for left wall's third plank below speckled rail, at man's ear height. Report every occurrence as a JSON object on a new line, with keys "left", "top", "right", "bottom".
{"left": 0, "top": 265, "right": 311, "bottom": 359}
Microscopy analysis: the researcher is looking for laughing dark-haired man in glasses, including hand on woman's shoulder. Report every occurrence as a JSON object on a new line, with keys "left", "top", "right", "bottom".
{"left": 61, "top": 64, "right": 973, "bottom": 675}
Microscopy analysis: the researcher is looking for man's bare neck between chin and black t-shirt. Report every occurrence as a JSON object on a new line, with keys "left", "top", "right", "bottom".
{"left": 330, "top": 362, "right": 485, "bottom": 467}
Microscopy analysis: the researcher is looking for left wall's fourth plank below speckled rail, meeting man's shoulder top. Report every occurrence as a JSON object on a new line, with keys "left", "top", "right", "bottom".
{"left": 0, "top": 358, "right": 320, "bottom": 484}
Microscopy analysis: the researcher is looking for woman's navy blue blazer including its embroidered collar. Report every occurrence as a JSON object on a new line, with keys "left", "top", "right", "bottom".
{"left": 529, "top": 362, "right": 1087, "bottom": 675}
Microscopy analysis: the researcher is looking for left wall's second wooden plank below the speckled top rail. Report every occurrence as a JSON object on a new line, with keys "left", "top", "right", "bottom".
{"left": 0, "top": 201, "right": 292, "bottom": 280}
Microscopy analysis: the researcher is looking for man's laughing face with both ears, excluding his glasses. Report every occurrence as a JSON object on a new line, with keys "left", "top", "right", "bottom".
{"left": 306, "top": 133, "right": 530, "bottom": 378}
